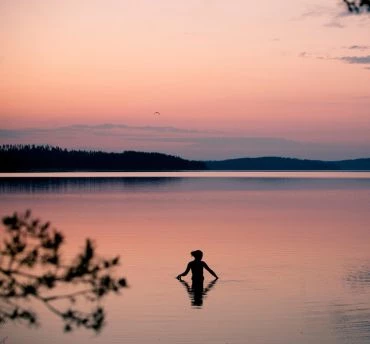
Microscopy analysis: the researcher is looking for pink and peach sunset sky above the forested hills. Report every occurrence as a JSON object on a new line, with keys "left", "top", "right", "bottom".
{"left": 0, "top": 0, "right": 370, "bottom": 160}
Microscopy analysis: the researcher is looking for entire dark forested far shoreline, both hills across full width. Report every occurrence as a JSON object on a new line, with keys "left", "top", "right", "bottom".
{"left": 0, "top": 145, "right": 370, "bottom": 172}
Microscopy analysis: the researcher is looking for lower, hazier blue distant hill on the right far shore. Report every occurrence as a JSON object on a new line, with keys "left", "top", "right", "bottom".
{"left": 206, "top": 157, "right": 370, "bottom": 171}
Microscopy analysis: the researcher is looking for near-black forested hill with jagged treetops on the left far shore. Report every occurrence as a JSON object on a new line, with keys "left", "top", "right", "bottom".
{"left": 0, "top": 145, "right": 206, "bottom": 172}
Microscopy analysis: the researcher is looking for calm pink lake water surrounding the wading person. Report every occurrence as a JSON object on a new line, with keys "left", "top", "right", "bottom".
{"left": 0, "top": 172, "right": 370, "bottom": 344}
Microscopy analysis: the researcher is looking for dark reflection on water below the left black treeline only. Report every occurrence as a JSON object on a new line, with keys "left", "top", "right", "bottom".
{"left": 0, "top": 177, "right": 182, "bottom": 193}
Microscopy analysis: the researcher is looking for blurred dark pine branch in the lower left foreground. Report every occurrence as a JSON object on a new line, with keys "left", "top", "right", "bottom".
{"left": 0, "top": 211, "right": 126, "bottom": 331}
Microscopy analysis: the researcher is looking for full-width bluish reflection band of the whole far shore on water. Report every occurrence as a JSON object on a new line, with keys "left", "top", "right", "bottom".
{"left": 0, "top": 174, "right": 370, "bottom": 195}
